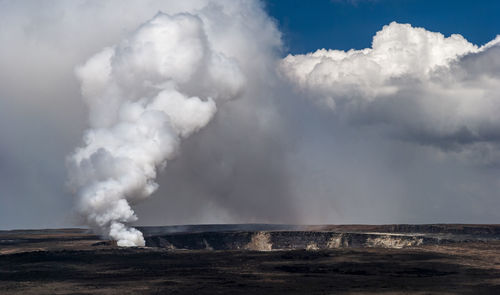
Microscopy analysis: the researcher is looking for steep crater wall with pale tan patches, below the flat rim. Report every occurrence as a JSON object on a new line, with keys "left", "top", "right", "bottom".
{"left": 147, "top": 230, "right": 488, "bottom": 251}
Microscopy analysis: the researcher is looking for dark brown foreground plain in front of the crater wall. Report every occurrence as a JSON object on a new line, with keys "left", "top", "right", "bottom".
{"left": 0, "top": 230, "right": 500, "bottom": 294}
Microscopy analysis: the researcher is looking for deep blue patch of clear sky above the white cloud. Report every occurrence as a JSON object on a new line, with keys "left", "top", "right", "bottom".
{"left": 266, "top": 0, "right": 500, "bottom": 54}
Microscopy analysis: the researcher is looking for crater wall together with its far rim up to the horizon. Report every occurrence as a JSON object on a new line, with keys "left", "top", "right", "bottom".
{"left": 141, "top": 225, "right": 500, "bottom": 251}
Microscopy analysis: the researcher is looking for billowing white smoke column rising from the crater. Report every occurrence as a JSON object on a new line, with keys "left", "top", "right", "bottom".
{"left": 68, "top": 13, "right": 245, "bottom": 246}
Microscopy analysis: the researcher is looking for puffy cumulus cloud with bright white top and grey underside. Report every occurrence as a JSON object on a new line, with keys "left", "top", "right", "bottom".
{"left": 280, "top": 22, "right": 500, "bottom": 156}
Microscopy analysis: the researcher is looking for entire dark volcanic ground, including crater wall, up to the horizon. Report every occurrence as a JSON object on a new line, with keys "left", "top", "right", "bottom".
{"left": 0, "top": 225, "right": 500, "bottom": 294}
